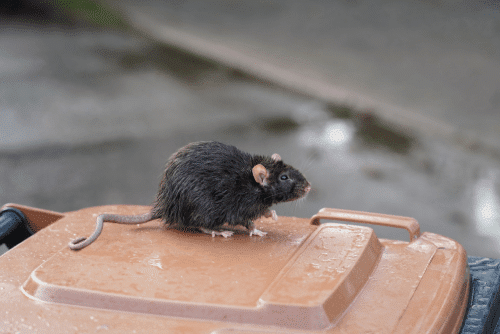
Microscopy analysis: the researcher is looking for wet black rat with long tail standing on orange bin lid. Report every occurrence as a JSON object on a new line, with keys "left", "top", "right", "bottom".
{"left": 69, "top": 141, "right": 311, "bottom": 250}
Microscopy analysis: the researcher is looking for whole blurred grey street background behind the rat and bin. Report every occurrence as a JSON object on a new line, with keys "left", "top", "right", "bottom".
{"left": 0, "top": 0, "right": 500, "bottom": 258}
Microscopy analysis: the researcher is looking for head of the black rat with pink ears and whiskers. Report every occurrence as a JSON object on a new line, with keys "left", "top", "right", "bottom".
{"left": 252, "top": 153, "right": 311, "bottom": 204}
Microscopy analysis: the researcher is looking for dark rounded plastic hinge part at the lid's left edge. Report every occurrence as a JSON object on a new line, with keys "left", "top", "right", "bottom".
{"left": 0, "top": 207, "right": 34, "bottom": 249}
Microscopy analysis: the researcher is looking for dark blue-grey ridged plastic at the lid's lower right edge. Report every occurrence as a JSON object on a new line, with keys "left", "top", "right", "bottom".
{"left": 460, "top": 256, "right": 500, "bottom": 334}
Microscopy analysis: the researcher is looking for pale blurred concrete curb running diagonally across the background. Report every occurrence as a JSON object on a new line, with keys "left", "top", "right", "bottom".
{"left": 113, "top": 3, "right": 500, "bottom": 155}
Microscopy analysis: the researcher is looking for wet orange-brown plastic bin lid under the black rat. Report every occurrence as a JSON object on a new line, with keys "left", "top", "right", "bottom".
{"left": 0, "top": 205, "right": 469, "bottom": 333}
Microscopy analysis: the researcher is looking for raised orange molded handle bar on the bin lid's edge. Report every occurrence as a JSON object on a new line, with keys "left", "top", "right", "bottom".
{"left": 311, "top": 208, "right": 420, "bottom": 242}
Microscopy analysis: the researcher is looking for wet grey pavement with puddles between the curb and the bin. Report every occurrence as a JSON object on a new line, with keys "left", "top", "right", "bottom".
{"left": 0, "top": 3, "right": 500, "bottom": 258}
